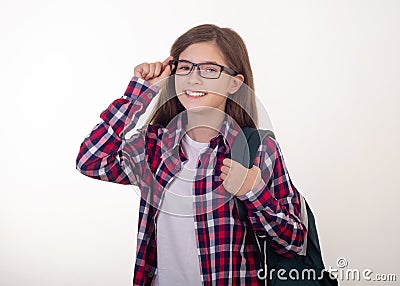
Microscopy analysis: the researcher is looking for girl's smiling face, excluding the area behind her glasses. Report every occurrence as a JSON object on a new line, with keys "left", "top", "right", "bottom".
{"left": 175, "top": 42, "right": 243, "bottom": 112}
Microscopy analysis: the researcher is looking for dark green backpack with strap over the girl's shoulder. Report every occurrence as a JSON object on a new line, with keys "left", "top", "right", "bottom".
{"left": 231, "top": 127, "right": 338, "bottom": 286}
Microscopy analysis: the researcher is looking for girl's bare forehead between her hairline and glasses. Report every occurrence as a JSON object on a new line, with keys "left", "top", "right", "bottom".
{"left": 179, "top": 42, "right": 225, "bottom": 65}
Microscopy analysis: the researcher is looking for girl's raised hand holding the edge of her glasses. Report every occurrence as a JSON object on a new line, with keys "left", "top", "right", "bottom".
{"left": 134, "top": 56, "right": 173, "bottom": 87}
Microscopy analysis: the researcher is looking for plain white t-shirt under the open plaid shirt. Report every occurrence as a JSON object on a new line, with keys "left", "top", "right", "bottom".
{"left": 155, "top": 134, "right": 208, "bottom": 286}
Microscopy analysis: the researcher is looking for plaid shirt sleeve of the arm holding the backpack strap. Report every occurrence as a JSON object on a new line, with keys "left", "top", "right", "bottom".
{"left": 238, "top": 136, "right": 307, "bottom": 257}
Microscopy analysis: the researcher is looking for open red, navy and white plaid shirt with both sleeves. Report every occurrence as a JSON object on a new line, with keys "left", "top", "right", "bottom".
{"left": 76, "top": 77, "right": 306, "bottom": 285}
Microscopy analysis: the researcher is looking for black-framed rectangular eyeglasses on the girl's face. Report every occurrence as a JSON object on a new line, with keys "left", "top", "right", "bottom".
{"left": 168, "top": 60, "right": 239, "bottom": 79}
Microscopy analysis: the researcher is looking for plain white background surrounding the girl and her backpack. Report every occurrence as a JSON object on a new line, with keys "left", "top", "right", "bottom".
{"left": 0, "top": 0, "right": 400, "bottom": 286}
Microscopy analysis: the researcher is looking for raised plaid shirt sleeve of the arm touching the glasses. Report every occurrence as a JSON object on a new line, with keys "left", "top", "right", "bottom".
{"left": 76, "top": 77, "right": 158, "bottom": 184}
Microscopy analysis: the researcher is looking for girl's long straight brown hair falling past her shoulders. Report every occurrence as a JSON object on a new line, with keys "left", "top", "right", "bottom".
{"left": 147, "top": 24, "right": 258, "bottom": 128}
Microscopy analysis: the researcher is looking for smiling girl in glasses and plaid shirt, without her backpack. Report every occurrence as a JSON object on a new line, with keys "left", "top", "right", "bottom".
{"left": 77, "top": 24, "right": 306, "bottom": 286}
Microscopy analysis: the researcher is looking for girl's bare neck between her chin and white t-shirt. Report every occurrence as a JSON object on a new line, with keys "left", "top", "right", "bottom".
{"left": 185, "top": 110, "right": 225, "bottom": 142}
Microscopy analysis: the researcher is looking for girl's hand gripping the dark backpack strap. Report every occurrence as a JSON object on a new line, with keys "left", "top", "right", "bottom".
{"left": 221, "top": 158, "right": 261, "bottom": 196}
